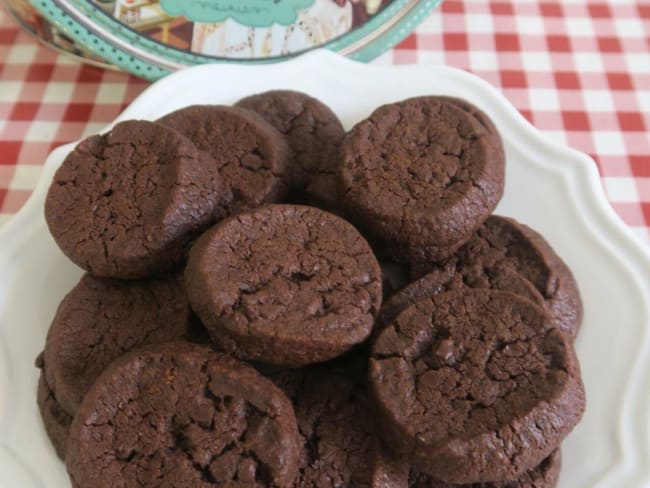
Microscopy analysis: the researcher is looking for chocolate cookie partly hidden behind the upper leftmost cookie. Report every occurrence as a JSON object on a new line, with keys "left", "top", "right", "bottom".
{"left": 158, "top": 105, "right": 291, "bottom": 217}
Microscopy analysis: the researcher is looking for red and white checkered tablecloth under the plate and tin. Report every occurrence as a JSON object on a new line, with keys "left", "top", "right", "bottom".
{"left": 0, "top": 0, "right": 650, "bottom": 243}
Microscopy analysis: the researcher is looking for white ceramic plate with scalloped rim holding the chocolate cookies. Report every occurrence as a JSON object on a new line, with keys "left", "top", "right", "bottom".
{"left": 0, "top": 52, "right": 650, "bottom": 488}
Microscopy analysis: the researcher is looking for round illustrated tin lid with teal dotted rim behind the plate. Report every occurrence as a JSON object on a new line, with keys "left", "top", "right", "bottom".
{"left": 30, "top": 0, "right": 441, "bottom": 79}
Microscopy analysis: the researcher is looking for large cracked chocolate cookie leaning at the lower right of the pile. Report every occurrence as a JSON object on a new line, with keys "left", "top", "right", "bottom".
{"left": 369, "top": 290, "right": 585, "bottom": 484}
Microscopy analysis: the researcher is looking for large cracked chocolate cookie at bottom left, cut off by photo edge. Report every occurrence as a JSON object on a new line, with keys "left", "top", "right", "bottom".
{"left": 66, "top": 343, "right": 301, "bottom": 488}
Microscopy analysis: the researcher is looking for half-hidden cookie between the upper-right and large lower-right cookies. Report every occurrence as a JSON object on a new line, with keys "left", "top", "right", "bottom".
{"left": 408, "top": 215, "right": 582, "bottom": 338}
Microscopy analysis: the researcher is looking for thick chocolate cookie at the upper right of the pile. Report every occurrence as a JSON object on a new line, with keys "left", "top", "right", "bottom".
{"left": 339, "top": 97, "right": 505, "bottom": 263}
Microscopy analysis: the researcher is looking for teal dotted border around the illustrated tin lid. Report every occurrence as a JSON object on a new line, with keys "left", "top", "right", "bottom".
{"left": 30, "top": 0, "right": 442, "bottom": 80}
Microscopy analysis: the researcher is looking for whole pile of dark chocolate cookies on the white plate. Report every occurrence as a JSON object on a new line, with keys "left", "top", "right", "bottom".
{"left": 37, "top": 91, "right": 585, "bottom": 488}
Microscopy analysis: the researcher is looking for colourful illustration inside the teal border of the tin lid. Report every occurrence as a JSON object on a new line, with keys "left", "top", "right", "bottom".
{"left": 93, "top": 0, "right": 392, "bottom": 59}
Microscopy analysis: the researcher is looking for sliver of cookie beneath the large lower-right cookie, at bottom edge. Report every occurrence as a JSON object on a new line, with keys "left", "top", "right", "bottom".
{"left": 408, "top": 449, "right": 562, "bottom": 488}
